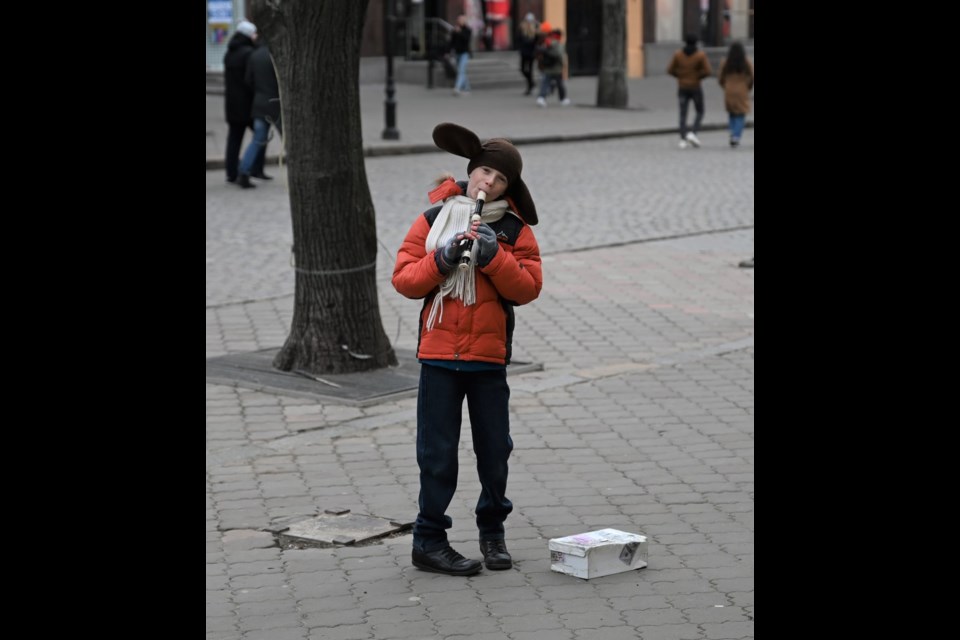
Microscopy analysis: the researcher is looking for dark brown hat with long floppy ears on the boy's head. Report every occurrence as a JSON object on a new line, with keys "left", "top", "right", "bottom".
{"left": 433, "top": 122, "right": 538, "bottom": 227}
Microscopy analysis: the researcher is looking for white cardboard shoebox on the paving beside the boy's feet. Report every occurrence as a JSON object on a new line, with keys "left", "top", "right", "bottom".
{"left": 549, "top": 529, "right": 647, "bottom": 580}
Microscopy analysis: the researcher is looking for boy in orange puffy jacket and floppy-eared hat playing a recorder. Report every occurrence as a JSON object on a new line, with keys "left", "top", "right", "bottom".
{"left": 393, "top": 122, "right": 543, "bottom": 576}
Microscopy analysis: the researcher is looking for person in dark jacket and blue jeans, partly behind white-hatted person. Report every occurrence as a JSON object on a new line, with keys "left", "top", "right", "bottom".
{"left": 237, "top": 45, "right": 283, "bottom": 189}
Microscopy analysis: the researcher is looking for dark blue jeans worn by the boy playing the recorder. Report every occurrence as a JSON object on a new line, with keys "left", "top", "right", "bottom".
{"left": 413, "top": 364, "right": 513, "bottom": 552}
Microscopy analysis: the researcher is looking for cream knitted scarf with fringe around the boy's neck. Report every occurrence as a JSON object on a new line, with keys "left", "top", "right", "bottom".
{"left": 424, "top": 196, "right": 507, "bottom": 331}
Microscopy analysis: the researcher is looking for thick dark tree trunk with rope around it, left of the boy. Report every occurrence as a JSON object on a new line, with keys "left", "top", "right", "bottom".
{"left": 249, "top": 0, "right": 397, "bottom": 374}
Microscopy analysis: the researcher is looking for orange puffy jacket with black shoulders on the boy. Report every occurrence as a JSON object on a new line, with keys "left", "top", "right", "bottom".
{"left": 393, "top": 189, "right": 543, "bottom": 364}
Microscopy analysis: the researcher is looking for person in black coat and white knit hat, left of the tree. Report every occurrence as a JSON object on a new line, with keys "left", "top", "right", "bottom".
{"left": 223, "top": 20, "right": 257, "bottom": 182}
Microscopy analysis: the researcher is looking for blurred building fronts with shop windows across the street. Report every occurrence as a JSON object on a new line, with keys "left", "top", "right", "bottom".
{"left": 205, "top": 0, "right": 754, "bottom": 86}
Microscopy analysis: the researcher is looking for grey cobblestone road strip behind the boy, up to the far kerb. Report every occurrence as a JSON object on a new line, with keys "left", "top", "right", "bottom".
{"left": 207, "top": 129, "right": 754, "bottom": 306}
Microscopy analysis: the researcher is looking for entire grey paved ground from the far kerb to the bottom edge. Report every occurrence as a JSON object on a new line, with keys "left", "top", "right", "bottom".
{"left": 206, "top": 112, "right": 754, "bottom": 640}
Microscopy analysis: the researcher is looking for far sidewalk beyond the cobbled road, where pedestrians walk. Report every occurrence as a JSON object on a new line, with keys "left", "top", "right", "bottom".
{"left": 206, "top": 72, "right": 754, "bottom": 170}
